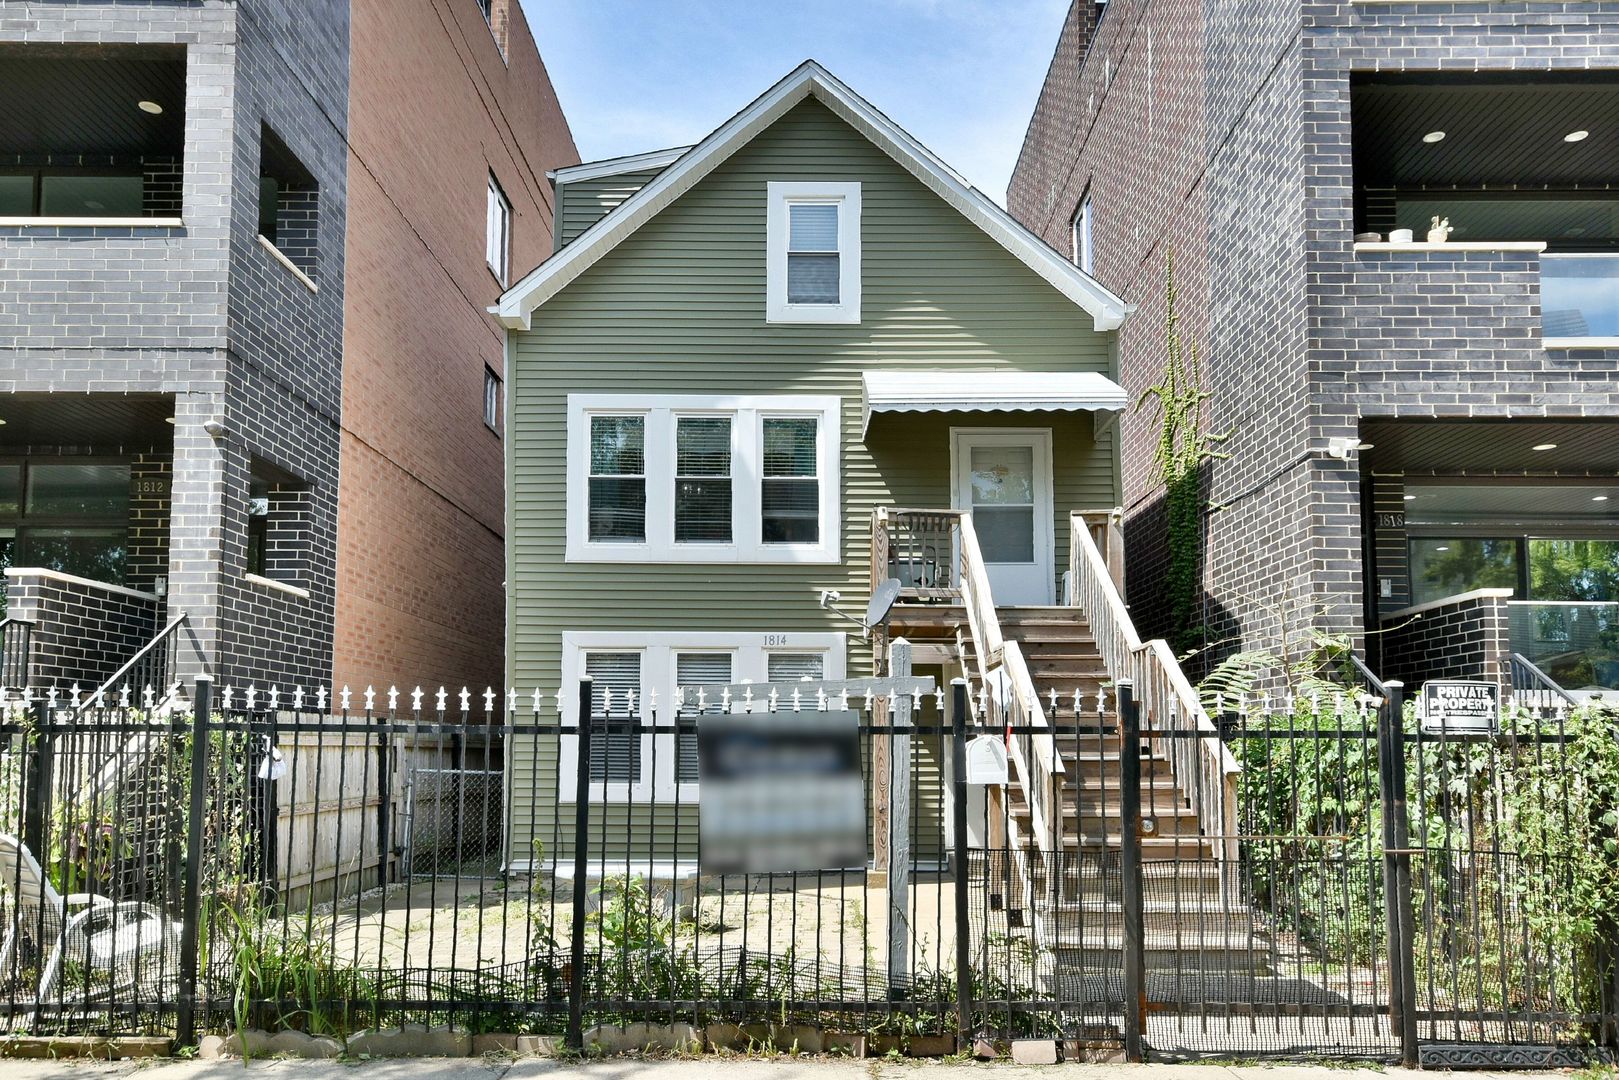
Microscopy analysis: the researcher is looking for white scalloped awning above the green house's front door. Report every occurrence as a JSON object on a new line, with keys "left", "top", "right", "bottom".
{"left": 860, "top": 371, "right": 1130, "bottom": 436}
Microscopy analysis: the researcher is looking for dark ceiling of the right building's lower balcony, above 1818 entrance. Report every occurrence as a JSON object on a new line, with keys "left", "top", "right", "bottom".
{"left": 1360, "top": 419, "right": 1619, "bottom": 476}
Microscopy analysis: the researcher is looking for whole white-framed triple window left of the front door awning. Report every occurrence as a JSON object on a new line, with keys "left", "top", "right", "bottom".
{"left": 567, "top": 393, "right": 840, "bottom": 563}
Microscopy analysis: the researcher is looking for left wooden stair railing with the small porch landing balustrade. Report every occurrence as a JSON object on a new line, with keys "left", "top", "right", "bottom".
{"left": 871, "top": 507, "right": 1065, "bottom": 853}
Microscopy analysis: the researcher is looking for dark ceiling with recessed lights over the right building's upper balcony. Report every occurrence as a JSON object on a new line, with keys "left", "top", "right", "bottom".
{"left": 1352, "top": 73, "right": 1619, "bottom": 188}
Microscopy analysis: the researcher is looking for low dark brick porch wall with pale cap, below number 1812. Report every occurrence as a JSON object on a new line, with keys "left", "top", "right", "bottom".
{"left": 6, "top": 573, "right": 159, "bottom": 691}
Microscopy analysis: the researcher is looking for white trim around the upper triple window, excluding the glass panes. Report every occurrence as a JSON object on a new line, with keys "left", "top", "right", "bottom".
{"left": 567, "top": 393, "right": 843, "bottom": 565}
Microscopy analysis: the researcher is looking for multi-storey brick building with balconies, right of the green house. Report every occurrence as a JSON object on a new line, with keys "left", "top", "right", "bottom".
{"left": 1009, "top": 0, "right": 1619, "bottom": 690}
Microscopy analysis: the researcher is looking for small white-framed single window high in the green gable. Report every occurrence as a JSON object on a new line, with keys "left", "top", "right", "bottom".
{"left": 764, "top": 181, "right": 860, "bottom": 324}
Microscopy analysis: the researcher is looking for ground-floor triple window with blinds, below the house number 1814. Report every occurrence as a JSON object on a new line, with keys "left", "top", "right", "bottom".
{"left": 559, "top": 630, "right": 845, "bottom": 801}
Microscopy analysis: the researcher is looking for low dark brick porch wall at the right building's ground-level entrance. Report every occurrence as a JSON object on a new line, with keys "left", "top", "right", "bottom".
{"left": 1381, "top": 589, "right": 1511, "bottom": 698}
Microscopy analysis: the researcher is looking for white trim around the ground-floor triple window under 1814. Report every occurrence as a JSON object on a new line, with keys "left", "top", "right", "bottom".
{"left": 557, "top": 630, "right": 848, "bottom": 805}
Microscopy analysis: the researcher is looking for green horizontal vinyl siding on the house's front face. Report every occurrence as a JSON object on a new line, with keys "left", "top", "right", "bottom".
{"left": 507, "top": 102, "right": 1117, "bottom": 858}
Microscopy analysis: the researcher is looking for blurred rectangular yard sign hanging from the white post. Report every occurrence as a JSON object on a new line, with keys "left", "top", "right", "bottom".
{"left": 698, "top": 711, "right": 866, "bottom": 874}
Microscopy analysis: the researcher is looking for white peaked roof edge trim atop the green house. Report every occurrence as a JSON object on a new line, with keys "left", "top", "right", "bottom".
{"left": 491, "top": 60, "right": 1133, "bottom": 330}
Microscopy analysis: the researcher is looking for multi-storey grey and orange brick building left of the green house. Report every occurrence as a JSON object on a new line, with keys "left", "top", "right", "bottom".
{"left": 0, "top": 0, "right": 576, "bottom": 685}
